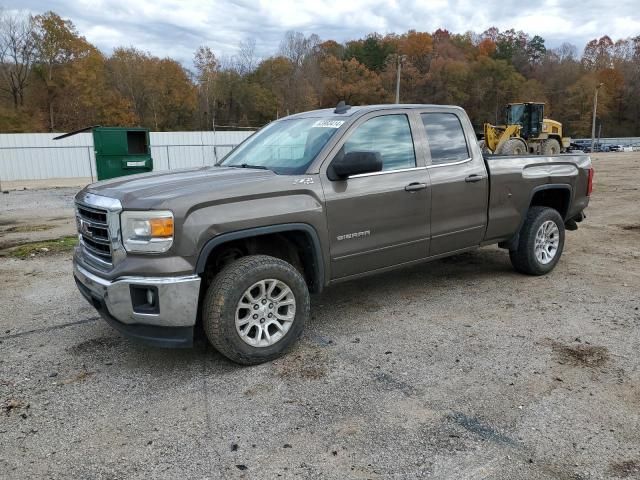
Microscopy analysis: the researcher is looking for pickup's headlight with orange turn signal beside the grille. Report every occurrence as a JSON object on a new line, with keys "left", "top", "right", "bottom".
{"left": 120, "top": 210, "right": 173, "bottom": 253}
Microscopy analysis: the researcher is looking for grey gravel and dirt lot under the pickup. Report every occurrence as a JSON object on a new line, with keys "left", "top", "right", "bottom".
{"left": 0, "top": 154, "right": 640, "bottom": 480}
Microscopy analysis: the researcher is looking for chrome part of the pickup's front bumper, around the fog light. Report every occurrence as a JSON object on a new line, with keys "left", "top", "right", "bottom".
{"left": 73, "top": 259, "right": 201, "bottom": 328}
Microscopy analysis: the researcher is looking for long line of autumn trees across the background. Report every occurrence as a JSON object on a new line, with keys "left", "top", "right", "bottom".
{"left": 0, "top": 8, "right": 640, "bottom": 136}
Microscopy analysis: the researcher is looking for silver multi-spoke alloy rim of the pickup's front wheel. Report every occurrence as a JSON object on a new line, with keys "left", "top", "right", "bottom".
{"left": 235, "top": 278, "right": 296, "bottom": 347}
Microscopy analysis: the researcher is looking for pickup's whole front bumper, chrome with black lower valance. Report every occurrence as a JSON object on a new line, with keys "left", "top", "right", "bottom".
{"left": 73, "top": 259, "right": 200, "bottom": 347}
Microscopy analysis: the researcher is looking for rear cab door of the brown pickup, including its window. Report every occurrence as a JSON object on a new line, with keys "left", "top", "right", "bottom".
{"left": 420, "top": 112, "right": 489, "bottom": 256}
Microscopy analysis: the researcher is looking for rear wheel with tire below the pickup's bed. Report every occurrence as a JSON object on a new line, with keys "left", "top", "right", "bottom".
{"left": 509, "top": 207, "right": 565, "bottom": 275}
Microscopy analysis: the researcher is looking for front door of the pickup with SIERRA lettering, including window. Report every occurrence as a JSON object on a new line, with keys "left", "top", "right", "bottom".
{"left": 321, "top": 110, "right": 429, "bottom": 279}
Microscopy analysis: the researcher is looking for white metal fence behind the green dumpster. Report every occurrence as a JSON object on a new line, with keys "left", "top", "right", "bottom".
{"left": 0, "top": 131, "right": 253, "bottom": 181}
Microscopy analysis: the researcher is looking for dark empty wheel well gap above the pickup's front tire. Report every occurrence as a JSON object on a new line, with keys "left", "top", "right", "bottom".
{"left": 201, "top": 230, "right": 322, "bottom": 292}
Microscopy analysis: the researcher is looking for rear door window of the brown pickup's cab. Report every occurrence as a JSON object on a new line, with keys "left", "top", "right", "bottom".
{"left": 421, "top": 113, "right": 469, "bottom": 165}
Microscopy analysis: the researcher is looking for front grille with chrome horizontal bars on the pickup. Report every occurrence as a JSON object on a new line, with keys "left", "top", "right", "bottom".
{"left": 76, "top": 204, "right": 113, "bottom": 268}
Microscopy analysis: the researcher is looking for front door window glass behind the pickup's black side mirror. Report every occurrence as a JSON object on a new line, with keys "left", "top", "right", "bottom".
{"left": 342, "top": 114, "right": 416, "bottom": 171}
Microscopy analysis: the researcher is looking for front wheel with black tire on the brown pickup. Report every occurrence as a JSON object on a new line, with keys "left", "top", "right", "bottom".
{"left": 202, "top": 255, "right": 310, "bottom": 365}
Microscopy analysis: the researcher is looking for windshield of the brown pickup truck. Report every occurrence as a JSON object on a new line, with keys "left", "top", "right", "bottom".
{"left": 220, "top": 118, "right": 344, "bottom": 175}
